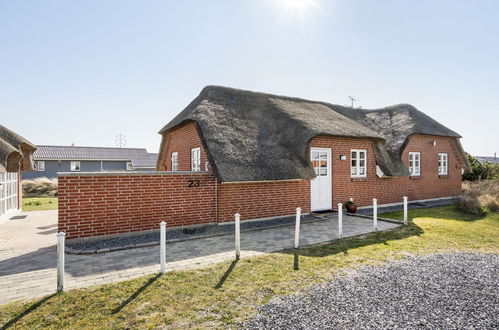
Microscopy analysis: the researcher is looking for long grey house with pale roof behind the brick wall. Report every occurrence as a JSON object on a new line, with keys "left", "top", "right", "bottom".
{"left": 24, "top": 145, "right": 157, "bottom": 179}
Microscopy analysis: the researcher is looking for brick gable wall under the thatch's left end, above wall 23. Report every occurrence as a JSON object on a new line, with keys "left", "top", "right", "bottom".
{"left": 158, "top": 122, "right": 208, "bottom": 171}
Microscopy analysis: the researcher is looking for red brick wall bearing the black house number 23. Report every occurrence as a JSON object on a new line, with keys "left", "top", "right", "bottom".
{"left": 59, "top": 173, "right": 216, "bottom": 239}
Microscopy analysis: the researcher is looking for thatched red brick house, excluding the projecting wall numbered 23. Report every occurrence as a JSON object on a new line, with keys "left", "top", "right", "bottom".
{"left": 157, "top": 86, "right": 470, "bottom": 214}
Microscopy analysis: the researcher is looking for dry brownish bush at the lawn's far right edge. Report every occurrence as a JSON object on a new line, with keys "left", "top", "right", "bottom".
{"left": 455, "top": 180, "right": 499, "bottom": 214}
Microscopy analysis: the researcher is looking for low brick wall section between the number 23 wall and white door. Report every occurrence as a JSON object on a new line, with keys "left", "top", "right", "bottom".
{"left": 218, "top": 180, "right": 310, "bottom": 222}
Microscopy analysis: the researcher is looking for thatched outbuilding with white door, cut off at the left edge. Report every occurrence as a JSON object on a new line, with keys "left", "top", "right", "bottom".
{"left": 0, "top": 125, "right": 36, "bottom": 220}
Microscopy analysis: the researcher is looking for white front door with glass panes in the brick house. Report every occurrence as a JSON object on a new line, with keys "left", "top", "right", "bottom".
{"left": 310, "top": 148, "right": 333, "bottom": 211}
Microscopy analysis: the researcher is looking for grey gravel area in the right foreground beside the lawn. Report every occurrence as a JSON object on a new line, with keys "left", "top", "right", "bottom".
{"left": 245, "top": 253, "right": 499, "bottom": 329}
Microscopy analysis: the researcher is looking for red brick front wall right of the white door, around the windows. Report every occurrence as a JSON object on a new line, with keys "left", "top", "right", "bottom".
{"left": 309, "top": 135, "right": 462, "bottom": 208}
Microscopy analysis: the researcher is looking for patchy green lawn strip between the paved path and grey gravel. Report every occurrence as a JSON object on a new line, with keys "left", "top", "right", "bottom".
{"left": 0, "top": 207, "right": 499, "bottom": 328}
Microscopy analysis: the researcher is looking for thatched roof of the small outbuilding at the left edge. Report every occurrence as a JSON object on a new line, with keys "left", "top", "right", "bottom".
{"left": 0, "top": 125, "right": 36, "bottom": 173}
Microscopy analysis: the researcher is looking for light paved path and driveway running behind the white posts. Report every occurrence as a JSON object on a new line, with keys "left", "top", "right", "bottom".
{"left": 0, "top": 211, "right": 399, "bottom": 304}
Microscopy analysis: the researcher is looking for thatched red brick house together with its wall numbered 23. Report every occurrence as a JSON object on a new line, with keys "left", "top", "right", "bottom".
{"left": 58, "top": 86, "right": 470, "bottom": 239}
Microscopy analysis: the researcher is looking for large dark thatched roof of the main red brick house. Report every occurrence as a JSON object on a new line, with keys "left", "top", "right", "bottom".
{"left": 160, "top": 86, "right": 468, "bottom": 182}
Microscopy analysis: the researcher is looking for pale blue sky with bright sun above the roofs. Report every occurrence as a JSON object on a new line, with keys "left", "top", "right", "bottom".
{"left": 0, "top": 0, "right": 499, "bottom": 155}
